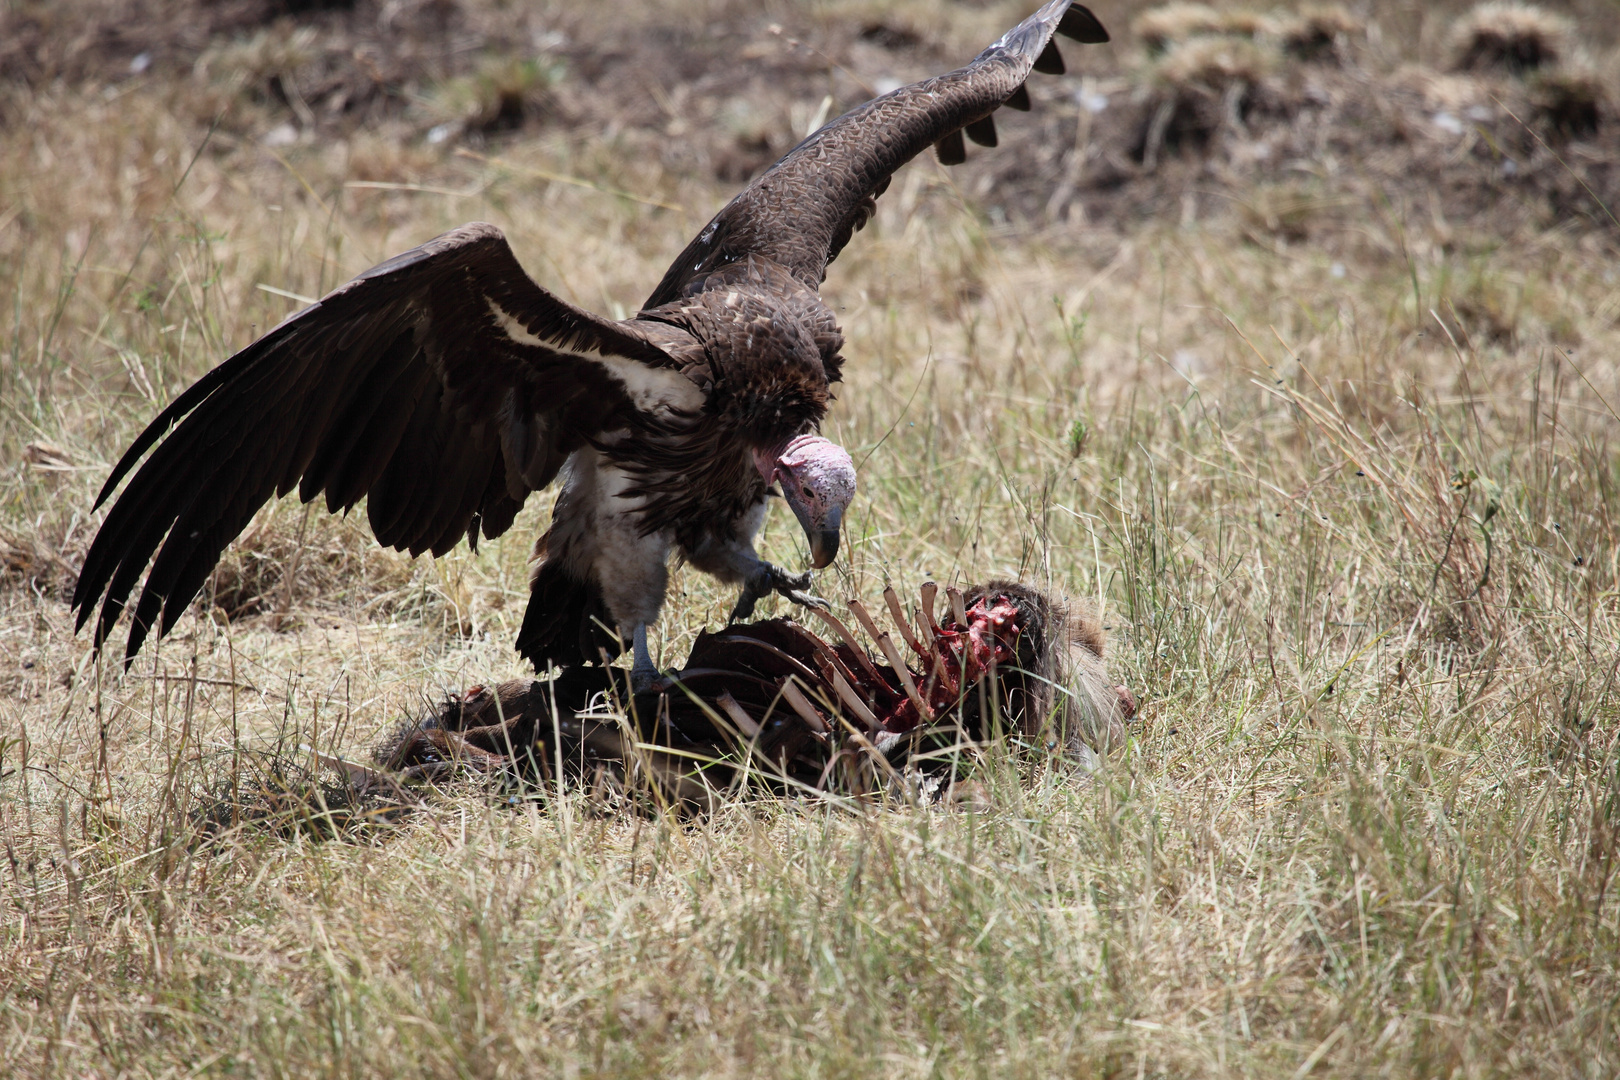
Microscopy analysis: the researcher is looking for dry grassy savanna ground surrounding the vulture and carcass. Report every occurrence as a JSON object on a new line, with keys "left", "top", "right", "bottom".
{"left": 0, "top": 0, "right": 1620, "bottom": 1077}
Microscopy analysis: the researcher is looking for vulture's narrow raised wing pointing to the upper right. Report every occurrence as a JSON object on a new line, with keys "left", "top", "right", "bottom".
{"left": 643, "top": 0, "right": 1108, "bottom": 311}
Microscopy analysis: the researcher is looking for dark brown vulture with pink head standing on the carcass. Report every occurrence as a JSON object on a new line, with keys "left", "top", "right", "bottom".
{"left": 73, "top": 0, "right": 1108, "bottom": 688}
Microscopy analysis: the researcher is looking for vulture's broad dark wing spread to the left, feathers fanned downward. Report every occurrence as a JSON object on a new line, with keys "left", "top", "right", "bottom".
{"left": 73, "top": 223, "right": 700, "bottom": 657}
